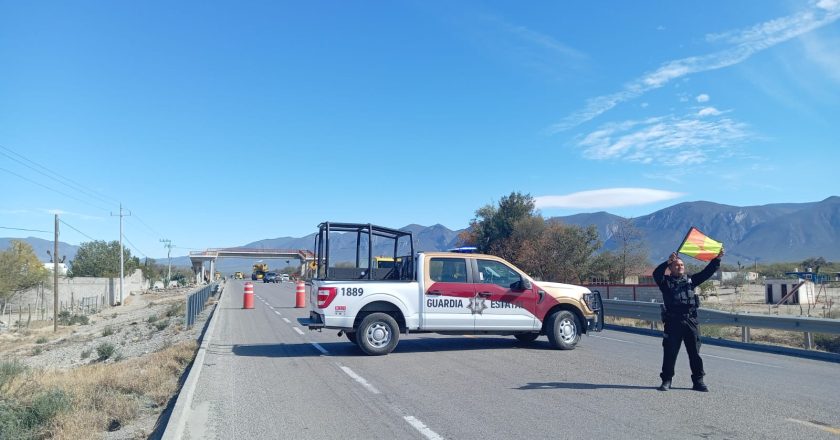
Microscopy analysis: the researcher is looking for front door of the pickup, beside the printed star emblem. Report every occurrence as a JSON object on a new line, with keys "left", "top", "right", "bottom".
{"left": 475, "top": 258, "right": 539, "bottom": 330}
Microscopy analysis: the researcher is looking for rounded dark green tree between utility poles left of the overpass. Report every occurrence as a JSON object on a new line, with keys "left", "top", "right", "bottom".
{"left": 68, "top": 240, "right": 140, "bottom": 278}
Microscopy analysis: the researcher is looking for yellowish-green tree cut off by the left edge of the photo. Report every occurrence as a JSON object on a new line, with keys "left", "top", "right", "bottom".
{"left": 0, "top": 240, "right": 50, "bottom": 311}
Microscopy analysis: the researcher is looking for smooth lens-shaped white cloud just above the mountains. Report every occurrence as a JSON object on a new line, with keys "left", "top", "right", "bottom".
{"left": 534, "top": 188, "right": 685, "bottom": 209}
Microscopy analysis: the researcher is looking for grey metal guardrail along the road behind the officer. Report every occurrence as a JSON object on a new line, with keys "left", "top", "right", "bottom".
{"left": 604, "top": 299, "right": 840, "bottom": 349}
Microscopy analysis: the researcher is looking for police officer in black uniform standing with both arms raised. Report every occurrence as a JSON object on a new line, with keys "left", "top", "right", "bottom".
{"left": 653, "top": 249, "right": 723, "bottom": 392}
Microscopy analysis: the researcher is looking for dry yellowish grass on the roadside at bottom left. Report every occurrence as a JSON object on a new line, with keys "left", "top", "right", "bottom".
{"left": 0, "top": 341, "right": 196, "bottom": 439}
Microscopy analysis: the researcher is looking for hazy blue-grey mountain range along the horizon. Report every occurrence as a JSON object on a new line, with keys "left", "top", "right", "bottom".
{"left": 0, "top": 196, "right": 840, "bottom": 273}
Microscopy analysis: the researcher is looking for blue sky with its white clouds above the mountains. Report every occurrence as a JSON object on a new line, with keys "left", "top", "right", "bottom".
{"left": 0, "top": 0, "right": 840, "bottom": 258}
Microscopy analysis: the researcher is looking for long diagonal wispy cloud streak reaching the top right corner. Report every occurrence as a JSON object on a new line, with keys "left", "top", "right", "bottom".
{"left": 549, "top": 0, "right": 840, "bottom": 132}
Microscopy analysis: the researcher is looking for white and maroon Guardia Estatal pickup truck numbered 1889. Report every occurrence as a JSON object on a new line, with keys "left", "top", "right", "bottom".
{"left": 300, "top": 222, "right": 603, "bottom": 355}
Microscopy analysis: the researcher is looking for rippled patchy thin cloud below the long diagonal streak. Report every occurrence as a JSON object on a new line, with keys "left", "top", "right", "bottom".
{"left": 576, "top": 111, "right": 750, "bottom": 166}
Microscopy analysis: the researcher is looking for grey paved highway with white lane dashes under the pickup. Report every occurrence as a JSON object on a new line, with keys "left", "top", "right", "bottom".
{"left": 185, "top": 281, "right": 840, "bottom": 440}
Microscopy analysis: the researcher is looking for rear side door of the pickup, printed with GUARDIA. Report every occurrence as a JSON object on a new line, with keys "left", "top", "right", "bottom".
{"left": 422, "top": 257, "right": 475, "bottom": 330}
